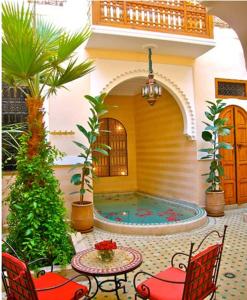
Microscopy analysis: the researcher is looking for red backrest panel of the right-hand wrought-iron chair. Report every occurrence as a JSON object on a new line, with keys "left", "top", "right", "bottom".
{"left": 183, "top": 244, "right": 223, "bottom": 300}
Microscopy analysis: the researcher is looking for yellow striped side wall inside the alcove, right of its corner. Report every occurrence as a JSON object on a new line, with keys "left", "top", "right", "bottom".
{"left": 135, "top": 91, "right": 197, "bottom": 202}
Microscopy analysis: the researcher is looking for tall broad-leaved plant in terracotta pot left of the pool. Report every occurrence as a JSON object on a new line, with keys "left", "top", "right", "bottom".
{"left": 71, "top": 94, "right": 111, "bottom": 233}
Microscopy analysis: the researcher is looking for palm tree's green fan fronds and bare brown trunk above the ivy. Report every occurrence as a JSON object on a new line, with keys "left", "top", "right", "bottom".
{"left": 2, "top": 3, "right": 93, "bottom": 158}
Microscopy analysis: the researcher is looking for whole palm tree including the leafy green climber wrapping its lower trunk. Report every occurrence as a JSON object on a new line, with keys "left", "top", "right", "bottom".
{"left": 2, "top": 2, "right": 93, "bottom": 264}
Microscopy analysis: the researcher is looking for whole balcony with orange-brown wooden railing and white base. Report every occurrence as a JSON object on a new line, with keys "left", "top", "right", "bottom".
{"left": 87, "top": 0, "right": 214, "bottom": 58}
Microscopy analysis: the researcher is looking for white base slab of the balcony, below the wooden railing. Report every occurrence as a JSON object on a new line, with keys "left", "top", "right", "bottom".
{"left": 86, "top": 25, "right": 215, "bottom": 58}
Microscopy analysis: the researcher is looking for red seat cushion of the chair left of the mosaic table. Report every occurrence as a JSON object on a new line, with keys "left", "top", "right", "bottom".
{"left": 33, "top": 272, "right": 88, "bottom": 300}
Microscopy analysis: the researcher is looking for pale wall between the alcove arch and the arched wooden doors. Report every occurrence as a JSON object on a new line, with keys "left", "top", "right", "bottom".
{"left": 193, "top": 28, "right": 247, "bottom": 204}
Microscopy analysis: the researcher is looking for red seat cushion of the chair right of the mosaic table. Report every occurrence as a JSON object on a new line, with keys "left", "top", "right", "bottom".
{"left": 137, "top": 267, "right": 186, "bottom": 300}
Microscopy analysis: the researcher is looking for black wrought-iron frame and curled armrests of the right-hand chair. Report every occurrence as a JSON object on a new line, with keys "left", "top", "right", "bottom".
{"left": 133, "top": 225, "right": 228, "bottom": 300}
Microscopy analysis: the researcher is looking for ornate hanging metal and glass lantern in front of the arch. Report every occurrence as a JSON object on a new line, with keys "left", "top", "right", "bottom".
{"left": 142, "top": 48, "right": 162, "bottom": 105}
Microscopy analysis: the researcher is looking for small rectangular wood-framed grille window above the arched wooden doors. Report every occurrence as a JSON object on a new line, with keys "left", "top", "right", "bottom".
{"left": 215, "top": 78, "right": 247, "bottom": 99}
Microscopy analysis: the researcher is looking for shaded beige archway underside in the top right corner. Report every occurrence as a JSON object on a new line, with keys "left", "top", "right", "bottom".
{"left": 201, "top": 1, "right": 247, "bottom": 68}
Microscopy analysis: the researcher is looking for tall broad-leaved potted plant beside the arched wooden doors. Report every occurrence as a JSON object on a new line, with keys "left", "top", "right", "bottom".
{"left": 199, "top": 99, "right": 232, "bottom": 217}
